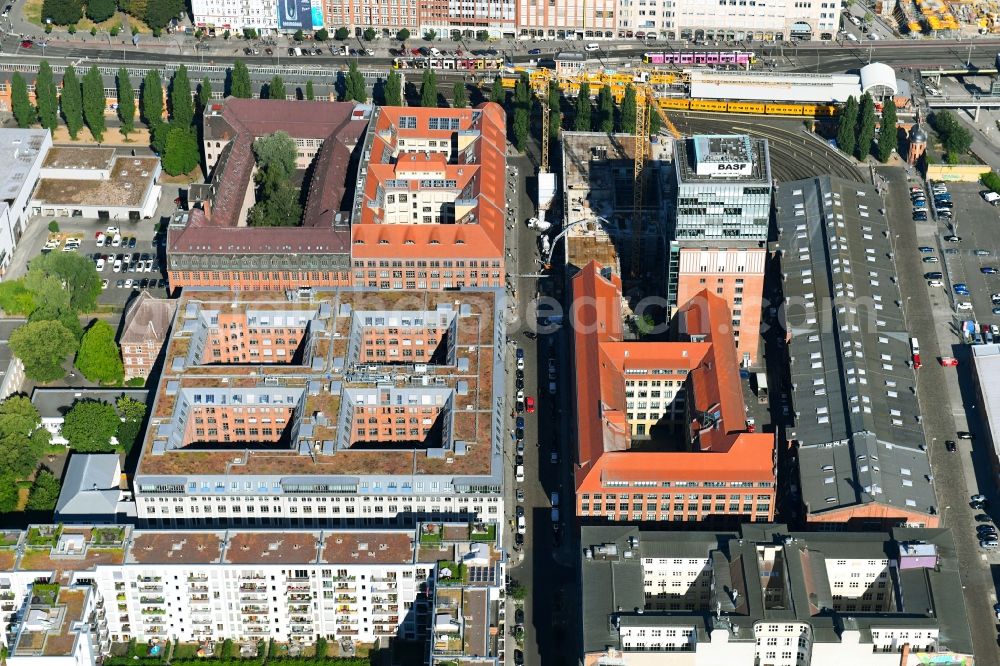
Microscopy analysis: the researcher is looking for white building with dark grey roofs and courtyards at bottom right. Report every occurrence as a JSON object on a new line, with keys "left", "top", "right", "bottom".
{"left": 581, "top": 524, "right": 972, "bottom": 666}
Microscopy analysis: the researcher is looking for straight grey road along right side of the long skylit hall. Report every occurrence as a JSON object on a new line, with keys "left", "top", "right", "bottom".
{"left": 878, "top": 163, "right": 1000, "bottom": 666}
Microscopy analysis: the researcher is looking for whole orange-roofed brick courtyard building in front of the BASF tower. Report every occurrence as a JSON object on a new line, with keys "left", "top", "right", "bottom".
{"left": 572, "top": 262, "right": 776, "bottom": 522}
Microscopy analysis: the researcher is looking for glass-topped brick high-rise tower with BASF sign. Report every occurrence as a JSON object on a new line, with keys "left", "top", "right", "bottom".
{"left": 667, "top": 135, "right": 771, "bottom": 365}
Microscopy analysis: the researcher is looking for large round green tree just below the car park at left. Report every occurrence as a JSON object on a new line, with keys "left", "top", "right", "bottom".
{"left": 26, "top": 252, "right": 101, "bottom": 312}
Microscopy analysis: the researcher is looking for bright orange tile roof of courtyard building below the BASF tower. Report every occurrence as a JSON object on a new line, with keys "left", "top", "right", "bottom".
{"left": 573, "top": 262, "right": 774, "bottom": 490}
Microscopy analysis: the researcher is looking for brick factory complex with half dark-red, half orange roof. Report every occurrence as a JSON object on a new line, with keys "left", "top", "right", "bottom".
{"left": 168, "top": 98, "right": 506, "bottom": 290}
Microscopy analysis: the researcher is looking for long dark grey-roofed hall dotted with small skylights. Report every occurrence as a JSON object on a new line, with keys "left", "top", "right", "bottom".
{"left": 775, "top": 177, "right": 941, "bottom": 527}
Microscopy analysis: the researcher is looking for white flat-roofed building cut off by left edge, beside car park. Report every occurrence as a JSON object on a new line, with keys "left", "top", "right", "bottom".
{"left": 0, "top": 129, "right": 52, "bottom": 276}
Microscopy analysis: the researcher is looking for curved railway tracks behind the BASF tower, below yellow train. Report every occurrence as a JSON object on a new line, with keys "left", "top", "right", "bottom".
{"left": 668, "top": 111, "right": 864, "bottom": 182}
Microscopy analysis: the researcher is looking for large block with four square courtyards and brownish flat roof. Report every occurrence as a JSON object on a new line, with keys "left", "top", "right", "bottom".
{"left": 134, "top": 288, "right": 507, "bottom": 527}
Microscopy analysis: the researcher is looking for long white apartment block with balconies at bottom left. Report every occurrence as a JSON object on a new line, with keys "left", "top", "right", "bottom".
{"left": 0, "top": 522, "right": 506, "bottom": 652}
